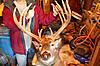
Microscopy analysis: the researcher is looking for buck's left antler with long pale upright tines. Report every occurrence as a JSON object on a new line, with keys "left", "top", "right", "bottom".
{"left": 13, "top": 4, "right": 40, "bottom": 42}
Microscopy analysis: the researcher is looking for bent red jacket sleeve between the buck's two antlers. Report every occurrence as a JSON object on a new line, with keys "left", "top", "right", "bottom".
{"left": 34, "top": 5, "right": 55, "bottom": 25}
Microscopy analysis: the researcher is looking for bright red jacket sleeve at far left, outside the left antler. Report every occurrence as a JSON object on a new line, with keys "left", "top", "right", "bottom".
{"left": 3, "top": 7, "right": 18, "bottom": 30}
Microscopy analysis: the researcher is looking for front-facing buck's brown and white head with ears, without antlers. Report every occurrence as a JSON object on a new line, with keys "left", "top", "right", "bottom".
{"left": 33, "top": 36, "right": 61, "bottom": 65}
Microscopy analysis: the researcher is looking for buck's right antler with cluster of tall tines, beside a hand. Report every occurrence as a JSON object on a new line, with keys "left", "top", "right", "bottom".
{"left": 52, "top": 0, "right": 71, "bottom": 40}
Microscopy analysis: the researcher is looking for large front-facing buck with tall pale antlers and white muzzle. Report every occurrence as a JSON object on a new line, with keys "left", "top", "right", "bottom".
{"left": 13, "top": 0, "right": 80, "bottom": 66}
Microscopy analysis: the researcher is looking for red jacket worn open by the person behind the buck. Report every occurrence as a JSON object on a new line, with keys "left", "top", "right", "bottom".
{"left": 3, "top": 5, "right": 55, "bottom": 54}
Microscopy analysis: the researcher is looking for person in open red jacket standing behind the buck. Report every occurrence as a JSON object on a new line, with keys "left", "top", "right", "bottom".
{"left": 3, "top": 0, "right": 55, "bottom": 66}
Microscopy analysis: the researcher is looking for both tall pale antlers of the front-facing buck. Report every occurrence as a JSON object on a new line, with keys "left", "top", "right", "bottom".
{"left": 13, "top": 0, "right": 80, "bottom": 42}
